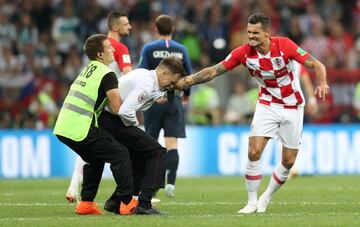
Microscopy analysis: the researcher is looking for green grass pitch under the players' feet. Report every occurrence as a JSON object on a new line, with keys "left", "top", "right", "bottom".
{"left": 0, "top": 176, "right": 360, "bottom": 227}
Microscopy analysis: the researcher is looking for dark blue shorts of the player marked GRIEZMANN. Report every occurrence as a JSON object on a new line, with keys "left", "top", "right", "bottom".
{"left": 144, "top": 96, "right": 186, "bottom": 139}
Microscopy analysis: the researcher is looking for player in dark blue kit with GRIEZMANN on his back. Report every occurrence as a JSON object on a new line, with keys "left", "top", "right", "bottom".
{"left": 139, "top": 15, "right": 192, "bottom": 197}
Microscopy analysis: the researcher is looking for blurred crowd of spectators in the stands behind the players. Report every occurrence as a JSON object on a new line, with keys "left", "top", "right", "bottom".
{"left": 0, "top": 0, "right": 360, "bottom": 129}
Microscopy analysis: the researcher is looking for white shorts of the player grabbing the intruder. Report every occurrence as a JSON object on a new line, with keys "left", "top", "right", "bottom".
{"left": 250, "top": 103, "right": 304, "bottom": 149}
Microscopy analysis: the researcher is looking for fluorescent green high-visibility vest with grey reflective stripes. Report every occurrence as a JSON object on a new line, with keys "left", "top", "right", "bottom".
{"left": 54, "top": 61, "right": 111, "bottom": 141}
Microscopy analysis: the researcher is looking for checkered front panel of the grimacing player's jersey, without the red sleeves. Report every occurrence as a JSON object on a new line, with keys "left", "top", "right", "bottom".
{"left": 245, "top": 45, "right": 304, "bottom": 109}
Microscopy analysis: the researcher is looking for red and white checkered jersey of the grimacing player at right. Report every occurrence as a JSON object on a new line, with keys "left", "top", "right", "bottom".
{"left": 222, "top": 37, "right": 309, "bottom": 109}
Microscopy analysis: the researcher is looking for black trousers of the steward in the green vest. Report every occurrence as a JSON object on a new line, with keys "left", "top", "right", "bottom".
{"left": 57, "top": 127, "right": 133, "bottom": 201}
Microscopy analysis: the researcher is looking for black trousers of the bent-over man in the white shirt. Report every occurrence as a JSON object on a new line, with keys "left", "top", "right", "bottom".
{"left": 98, "top": 111, "right": 166, "bottom": 195}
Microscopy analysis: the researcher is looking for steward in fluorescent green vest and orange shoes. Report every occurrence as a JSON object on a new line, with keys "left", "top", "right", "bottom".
{"left": 54, "top": 34, "right": 137, "bottom": 214}
